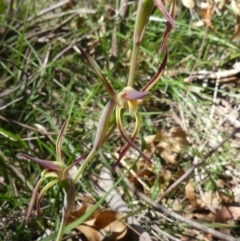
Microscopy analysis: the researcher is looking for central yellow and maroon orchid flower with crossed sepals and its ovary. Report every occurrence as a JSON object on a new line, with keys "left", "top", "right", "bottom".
{"left": 78, "top": 43, "right": 168, "bottom": 168}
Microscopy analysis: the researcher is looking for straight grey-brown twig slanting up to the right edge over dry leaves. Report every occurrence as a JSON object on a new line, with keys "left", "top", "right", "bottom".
{"left": 156, "top": 128, "right": 240, "bottom": 202}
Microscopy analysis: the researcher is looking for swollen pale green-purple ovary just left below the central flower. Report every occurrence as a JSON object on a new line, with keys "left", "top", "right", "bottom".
{"left": 93, "top": 100, "right": 116, "bottom": 150}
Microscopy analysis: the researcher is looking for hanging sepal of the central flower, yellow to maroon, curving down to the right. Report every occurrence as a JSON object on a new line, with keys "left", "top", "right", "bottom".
{"left": 116, "top": 107, "right": 152, "bottom": 163}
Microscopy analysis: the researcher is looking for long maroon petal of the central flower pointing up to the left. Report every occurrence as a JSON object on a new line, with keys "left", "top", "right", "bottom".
{"left": 78, "top": 46, "right": 117, "bottom": 103}
